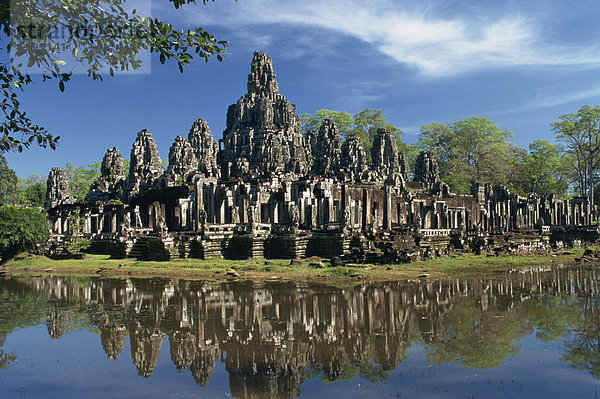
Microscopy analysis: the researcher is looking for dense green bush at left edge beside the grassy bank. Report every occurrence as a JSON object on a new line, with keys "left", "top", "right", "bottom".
{"left": 0, "top": 206, "right": 48, "bottom": 263}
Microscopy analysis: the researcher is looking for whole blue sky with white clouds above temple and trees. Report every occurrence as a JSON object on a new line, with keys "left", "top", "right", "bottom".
{"left": 7, "top": 0, "right": 600, "bottom": 177}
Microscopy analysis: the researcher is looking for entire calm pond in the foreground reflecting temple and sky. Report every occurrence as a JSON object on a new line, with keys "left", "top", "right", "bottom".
{"left": 0, "top": 268, "right": 600, "bottom": 399}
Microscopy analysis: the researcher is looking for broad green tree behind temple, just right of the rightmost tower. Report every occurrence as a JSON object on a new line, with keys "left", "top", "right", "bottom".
{"left": 417, "top": 117, "right": 515, "bottom": 194}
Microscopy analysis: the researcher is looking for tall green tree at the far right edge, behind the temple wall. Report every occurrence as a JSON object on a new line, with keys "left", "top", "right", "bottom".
{"left": 551, "top": 105, "right": 600, "bottom": 206}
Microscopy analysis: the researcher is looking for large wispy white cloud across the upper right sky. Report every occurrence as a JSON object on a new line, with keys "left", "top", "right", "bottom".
{"left": 173, "top": 0, "right": 600, "bottom": 77}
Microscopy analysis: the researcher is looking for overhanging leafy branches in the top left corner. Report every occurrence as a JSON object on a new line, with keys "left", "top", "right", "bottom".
{"left": 0, "top": 0, "right": 228, "bottom": 154}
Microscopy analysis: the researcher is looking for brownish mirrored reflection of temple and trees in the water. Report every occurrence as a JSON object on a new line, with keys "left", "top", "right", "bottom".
{"left": 0, "top": 269, "right": 600, "bottom": 398}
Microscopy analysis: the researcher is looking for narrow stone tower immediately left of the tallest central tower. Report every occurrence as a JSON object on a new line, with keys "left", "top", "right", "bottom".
{"left": 188, "top": 119, "right": 219, "bottom": 177}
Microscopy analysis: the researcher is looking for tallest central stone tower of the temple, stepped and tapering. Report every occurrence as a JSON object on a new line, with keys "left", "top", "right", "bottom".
{"left": 218, "top": 52, "right": 309, "bottom": 178}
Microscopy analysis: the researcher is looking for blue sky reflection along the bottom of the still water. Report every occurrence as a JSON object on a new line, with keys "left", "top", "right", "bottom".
{"left": 0, "top": 325, "right": 600, "bottom": 399}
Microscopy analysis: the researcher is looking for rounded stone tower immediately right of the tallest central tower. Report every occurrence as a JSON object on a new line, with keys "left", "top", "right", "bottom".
{"left": 308, "top": 119, "right": 342, "bottom": 177}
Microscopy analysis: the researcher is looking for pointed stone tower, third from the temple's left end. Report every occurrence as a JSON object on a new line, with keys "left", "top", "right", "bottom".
{"left": 126, "top": 129, "right": 163, "bottom": 196}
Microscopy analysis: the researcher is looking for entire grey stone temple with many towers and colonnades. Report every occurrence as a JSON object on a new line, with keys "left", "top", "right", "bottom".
{"left": 46, "top": 52, "right": 598, "bottom": 263}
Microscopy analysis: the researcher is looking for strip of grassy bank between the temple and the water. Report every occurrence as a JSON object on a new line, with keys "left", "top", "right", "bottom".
{"left": 2, "top": 249, "right": 583, "bottom": 283}
